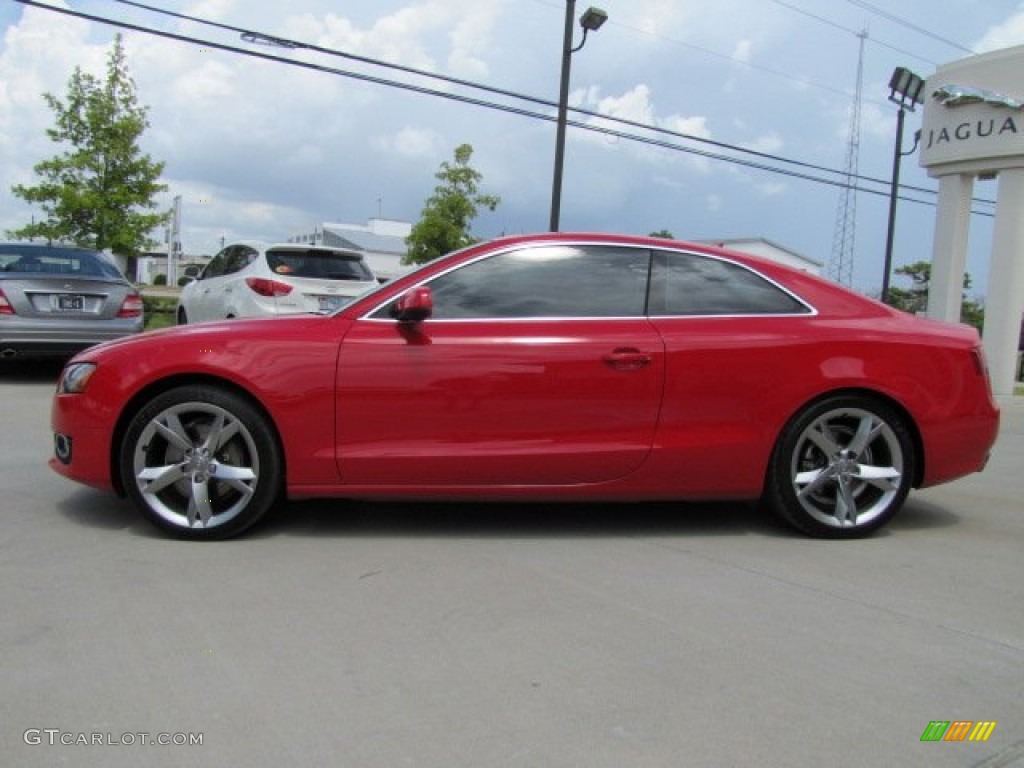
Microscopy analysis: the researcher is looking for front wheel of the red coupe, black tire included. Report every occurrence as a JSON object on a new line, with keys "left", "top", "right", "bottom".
{"left": 121, "top": 386, "right": 281, "bottom": 539}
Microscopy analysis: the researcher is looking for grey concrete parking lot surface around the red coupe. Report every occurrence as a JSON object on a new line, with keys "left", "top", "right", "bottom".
{"left": 6, "top": 365, "right": 1024, "bottom": 768}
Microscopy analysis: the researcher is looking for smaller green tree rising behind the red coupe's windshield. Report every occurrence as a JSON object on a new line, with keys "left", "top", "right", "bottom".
{"left": 402, "top": 144, "right": 501, "bottom": 264}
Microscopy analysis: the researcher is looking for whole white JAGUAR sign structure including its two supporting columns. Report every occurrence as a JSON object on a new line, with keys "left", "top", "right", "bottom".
{"left": 921, "top": 46, "right": 1024, "bottom": 394}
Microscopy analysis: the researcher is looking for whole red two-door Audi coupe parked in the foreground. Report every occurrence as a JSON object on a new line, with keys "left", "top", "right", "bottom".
{"left": 50, "top": 233, "right": 998, "bottom": 539}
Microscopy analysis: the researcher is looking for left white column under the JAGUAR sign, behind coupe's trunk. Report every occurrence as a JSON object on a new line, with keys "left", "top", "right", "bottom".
{"left": 928, "top": 173, "right": 974, "bottom": 323}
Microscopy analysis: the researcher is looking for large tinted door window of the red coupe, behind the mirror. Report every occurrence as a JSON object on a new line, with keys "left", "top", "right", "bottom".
{"left": 387, "top": 245, "right": 650, "bottom": 319}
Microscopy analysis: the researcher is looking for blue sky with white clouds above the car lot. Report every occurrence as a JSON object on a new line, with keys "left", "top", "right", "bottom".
{"left": 0, "top": 0, "right": 1024, "bottom": 293}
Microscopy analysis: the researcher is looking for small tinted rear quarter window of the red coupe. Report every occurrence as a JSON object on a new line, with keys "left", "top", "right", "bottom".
{"left": 650, "top": 251, "right": 810, "bottom": 316}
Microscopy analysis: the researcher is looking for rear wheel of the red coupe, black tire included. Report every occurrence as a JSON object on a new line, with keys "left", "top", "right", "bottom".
{"left": 766, "top": 396, "right": 915, "bottom": 538}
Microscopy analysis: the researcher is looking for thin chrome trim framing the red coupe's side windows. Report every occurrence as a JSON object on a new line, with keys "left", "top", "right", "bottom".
{"left": 358, "top": 240, "right": 818, "bottom": 325}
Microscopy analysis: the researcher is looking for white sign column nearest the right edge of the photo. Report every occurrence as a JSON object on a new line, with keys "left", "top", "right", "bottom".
{"left": 985, "top": 168, "right": 1024, "bottom": 394}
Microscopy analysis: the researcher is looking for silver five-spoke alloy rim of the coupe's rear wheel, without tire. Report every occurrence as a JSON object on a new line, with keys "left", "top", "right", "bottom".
{"left": 790, "top": 408, "right": 904, "bottom": 528}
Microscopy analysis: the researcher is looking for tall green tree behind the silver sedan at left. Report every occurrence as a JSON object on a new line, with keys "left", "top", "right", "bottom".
{"left": 8, "top": 35, "right": 169, "bottom": 255}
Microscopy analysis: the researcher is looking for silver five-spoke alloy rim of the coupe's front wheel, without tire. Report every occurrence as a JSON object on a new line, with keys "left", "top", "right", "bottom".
{"left": 133, "top": 401, "right": 259, "bottom": 528}
